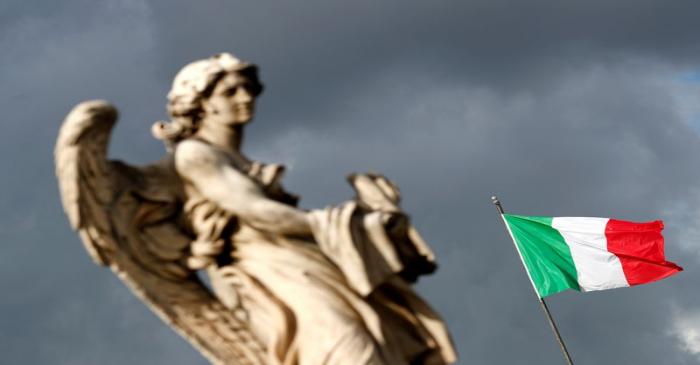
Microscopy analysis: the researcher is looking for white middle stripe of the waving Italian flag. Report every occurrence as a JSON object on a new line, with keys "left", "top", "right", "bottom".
{"left": 552, "top": 217, "right": 629, "bottom": 291}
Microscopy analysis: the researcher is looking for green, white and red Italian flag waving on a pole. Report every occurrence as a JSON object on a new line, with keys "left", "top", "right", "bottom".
{"left": 503, "top": 214, "right": 683, "bottom": 298}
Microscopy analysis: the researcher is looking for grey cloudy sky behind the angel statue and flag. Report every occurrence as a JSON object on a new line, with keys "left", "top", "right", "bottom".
{"left": 0, "top": 0, "right": 700, "bottom": 365}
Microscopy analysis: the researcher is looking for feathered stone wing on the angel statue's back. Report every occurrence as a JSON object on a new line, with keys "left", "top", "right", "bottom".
{"left": 55, "top": 101, "right": 269, "bottom": 365}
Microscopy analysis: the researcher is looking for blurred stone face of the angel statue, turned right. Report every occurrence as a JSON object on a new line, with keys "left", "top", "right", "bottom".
{"left": 202, "top": 73, "right": 255, "bottom": 125}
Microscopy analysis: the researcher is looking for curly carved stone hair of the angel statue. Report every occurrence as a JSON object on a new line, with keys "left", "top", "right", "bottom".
{"left": 152, "top": 53, "right": 263, "bottom": 148}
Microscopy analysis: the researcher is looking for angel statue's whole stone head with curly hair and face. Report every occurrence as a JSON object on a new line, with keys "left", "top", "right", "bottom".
{"left": 153, "top": 53, "right": 263, "bottom": 144}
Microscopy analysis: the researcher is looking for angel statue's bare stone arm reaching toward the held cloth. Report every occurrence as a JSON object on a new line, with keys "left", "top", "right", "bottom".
{"left": 175, "top": 140, "right": 311, "bottom": 235}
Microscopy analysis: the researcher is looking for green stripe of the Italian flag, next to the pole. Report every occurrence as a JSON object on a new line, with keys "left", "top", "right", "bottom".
{"left": 503, "top": 214, "right": 580, "bottom": 298}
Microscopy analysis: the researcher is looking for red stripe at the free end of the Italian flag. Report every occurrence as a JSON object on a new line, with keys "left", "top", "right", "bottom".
{"left": 605, "top": 219, "right": 683, "bottom": 285}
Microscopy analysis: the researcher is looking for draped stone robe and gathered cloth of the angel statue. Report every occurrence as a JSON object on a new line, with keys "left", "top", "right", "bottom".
{"left": 185, "top": 165, "right": 456, "bottom": 365}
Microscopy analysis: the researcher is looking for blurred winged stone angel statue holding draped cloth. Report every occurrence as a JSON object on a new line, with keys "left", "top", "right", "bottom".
{"left": 55, "top": 53, "right": 456, "bottom": 365}
